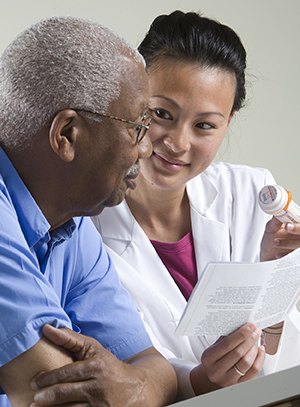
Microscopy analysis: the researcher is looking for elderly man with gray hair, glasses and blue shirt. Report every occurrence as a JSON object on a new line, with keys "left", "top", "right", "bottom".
{"left": 0, "top": 17, "right": 176, "bottom": 407}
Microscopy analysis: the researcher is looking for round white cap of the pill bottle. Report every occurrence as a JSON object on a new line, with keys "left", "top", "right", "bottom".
{"left": 258, "top": 185, "right": 288, "bottom": 215}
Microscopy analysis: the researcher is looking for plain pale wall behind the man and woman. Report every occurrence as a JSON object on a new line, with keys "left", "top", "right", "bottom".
{"left": 0, "top": 0, "right": 300, "bottom": 201}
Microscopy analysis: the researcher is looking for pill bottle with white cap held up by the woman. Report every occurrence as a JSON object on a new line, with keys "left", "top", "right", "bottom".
{"left": 258, "top": 185, "right": 300, "bottom": 223}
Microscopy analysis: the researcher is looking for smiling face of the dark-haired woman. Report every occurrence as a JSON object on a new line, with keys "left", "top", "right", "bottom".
{"left": 141, "top": 62, "right": 236, "bottom": 189}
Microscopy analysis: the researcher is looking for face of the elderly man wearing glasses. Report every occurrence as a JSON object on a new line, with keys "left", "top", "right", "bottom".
{"left": 74, "top": 59, "right": 152, "bottom": 216}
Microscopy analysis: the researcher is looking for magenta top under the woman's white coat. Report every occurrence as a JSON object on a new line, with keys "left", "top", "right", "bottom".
{"left": 150, "top": 232, "right": 198, "bottom": 300}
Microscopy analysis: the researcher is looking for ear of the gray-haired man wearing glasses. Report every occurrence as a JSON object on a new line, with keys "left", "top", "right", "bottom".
{"left": 49, "top": 109, "right": 80, "bottom": 162}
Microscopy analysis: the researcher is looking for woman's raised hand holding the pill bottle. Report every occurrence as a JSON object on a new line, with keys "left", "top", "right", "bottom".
{"left": 260, "top": 217, "right": 300, "bottom": 261}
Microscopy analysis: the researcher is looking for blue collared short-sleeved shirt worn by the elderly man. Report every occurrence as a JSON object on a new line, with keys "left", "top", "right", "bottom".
{"left": 0, "top": 148, "right": 152, "bottom": 405}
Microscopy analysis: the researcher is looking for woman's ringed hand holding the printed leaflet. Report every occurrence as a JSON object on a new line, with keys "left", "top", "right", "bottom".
{"left": 190, "top": 323, "right": 265, "bottom": 395}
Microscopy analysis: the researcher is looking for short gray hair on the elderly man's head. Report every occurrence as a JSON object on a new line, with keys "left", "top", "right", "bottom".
{"left": 0, "top": 17, "right": 143, "bottom": 149}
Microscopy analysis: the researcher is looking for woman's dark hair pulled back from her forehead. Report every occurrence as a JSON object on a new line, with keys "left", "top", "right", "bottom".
{"left": 138, "top": 10, "right": 246, "bottom": 111}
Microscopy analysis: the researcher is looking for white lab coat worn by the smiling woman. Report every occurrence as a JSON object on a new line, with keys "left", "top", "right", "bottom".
{"left": 93, "top": 163, "right": 300, "bottom": 398}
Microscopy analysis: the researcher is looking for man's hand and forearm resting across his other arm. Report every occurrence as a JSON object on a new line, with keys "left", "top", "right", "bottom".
{"left": 31, "top": 325, "right": 177, "bottom": 407}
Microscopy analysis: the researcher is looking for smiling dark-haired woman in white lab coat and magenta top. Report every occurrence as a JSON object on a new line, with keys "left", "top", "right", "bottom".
{"left": 93, "top": 11, "right": 300, "bottom": 398}
